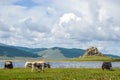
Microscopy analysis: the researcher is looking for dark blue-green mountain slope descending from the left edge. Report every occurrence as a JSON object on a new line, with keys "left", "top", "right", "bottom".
{"left": 0, "top": 45, "right": 40, "bottom": 58}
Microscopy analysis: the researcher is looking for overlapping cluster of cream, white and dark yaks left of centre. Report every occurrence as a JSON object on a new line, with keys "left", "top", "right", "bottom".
{"left": 25, "top": 61, "right": 50, "bottom": 72}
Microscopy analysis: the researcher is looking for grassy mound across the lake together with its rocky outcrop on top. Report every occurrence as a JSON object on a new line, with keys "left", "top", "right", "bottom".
{"left": 67, "top": 46, "right": 120, "bottom": 61}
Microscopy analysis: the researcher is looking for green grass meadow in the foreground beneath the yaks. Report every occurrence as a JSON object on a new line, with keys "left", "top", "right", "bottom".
{"left": 0, "top": 68, "right": 120, "bottom": 80}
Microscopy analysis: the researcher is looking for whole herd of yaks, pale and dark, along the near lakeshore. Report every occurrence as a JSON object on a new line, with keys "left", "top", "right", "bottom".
{"left": 4, "top": 61, "right": 112, "bottom": 72}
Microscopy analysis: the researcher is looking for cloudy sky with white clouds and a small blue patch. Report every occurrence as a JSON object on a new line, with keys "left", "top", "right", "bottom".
{"left": 0, "top": 0, "right": 120, "bottom": 55}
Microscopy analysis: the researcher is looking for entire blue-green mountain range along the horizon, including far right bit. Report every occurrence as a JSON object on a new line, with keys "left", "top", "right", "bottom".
{"left": 0, "top": 43, "right": 120, "bottom": 59}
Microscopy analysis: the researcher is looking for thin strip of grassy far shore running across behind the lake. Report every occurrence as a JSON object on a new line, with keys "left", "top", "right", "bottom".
{"left": 0, "top": 57, "right": 120, "bottom": 62}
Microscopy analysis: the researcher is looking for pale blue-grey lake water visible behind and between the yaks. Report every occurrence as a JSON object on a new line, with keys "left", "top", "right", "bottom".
{"left": 0, "top": 61, "right": 120, "bottom": 68}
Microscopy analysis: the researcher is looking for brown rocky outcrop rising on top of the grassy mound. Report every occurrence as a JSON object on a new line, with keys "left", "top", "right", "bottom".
{"left": 84, "top": 47, "right": 103, "bottom": 56}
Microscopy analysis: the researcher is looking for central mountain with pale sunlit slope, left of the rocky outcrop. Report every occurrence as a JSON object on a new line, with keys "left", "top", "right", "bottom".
{"left": 37, "top": 47, "right": 84, "bottom": 59}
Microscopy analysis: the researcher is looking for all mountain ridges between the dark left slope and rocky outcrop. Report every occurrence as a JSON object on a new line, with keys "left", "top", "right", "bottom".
{"left": 16, "top": 47, "right": 85, "bottom": 59}
